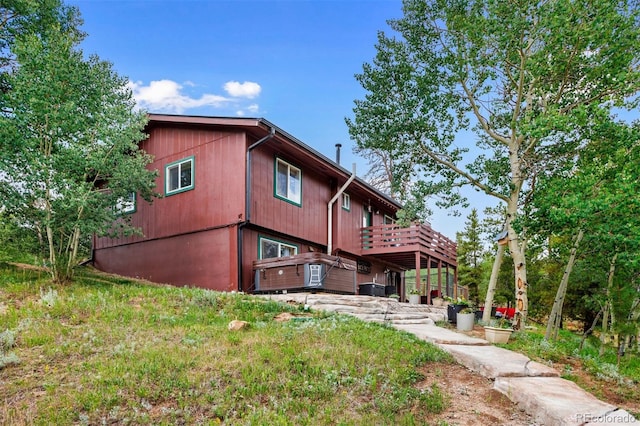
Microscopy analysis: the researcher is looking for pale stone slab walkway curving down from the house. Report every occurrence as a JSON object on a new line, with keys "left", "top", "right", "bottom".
{"left": 263, "top": 293, "right": 640, "bottom": 425}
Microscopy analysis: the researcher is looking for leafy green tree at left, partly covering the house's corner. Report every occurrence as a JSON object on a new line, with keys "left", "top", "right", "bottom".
{"left": 0, "top": 0, "right": 155, "bottom": 282}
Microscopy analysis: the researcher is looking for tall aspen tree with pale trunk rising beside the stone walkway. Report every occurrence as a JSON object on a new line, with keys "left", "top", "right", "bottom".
{"left": 347, "top": 0, "right": 640, "bottom": 325}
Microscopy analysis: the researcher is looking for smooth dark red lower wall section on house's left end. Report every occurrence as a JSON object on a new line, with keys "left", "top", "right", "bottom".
{"left": 94, "top": 226, "right": 238, "bottom": 291}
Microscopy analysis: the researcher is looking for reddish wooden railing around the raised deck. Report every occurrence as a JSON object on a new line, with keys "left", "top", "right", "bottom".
{"left": 361, "top": 224, "right": 456, "bottom": 262}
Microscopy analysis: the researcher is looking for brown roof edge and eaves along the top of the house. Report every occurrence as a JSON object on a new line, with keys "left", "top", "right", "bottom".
{"left": 147, "top": 113, "right": 402, "bottom": 209}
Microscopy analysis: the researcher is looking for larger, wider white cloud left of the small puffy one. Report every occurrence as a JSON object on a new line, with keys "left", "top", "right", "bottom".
{"left": 128, "top": 80, "right": 230, "bottom": 114}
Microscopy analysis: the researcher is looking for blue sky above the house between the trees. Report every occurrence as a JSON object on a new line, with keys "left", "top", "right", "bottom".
{"left": 67, "top": 0, "right": 484, "bottom": 239}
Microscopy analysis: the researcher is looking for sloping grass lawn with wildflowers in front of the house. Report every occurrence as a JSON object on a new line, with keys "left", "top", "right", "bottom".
{"left": 0, "top": 263, "right": 453, "bottom": 425}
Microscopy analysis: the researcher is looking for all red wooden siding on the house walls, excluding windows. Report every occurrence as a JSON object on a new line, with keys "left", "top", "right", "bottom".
{"left": 94, "top": 118, "right": 456, "bottom": 291}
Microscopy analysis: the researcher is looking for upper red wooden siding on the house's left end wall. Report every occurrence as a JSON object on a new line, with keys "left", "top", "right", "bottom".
{"left": 95, "top": 127, "right": 246, "bottom": 249}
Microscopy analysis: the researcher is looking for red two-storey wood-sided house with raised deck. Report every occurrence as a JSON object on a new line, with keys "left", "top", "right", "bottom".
{"left": 93, "top": 114, "right": 457, "bottom": 297}
